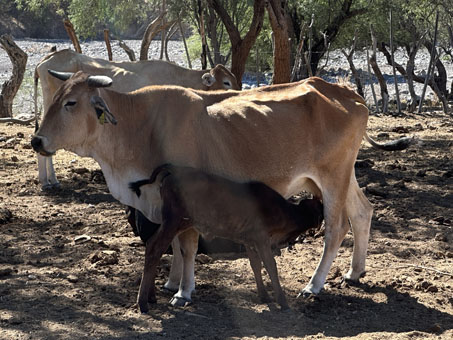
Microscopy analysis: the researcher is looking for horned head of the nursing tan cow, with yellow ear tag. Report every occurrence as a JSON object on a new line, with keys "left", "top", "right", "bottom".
{"left": 31, "top": 70, "right": 116, "bottom": 156}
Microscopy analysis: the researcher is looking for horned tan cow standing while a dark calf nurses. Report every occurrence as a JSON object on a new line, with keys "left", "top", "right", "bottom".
{"left": 32, "top": 72, "right": 373, "bottom": 304}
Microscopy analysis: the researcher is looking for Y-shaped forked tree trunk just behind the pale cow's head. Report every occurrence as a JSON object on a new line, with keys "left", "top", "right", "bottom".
{"left": 207, "top": 0, "right": 265, "bottom": 86}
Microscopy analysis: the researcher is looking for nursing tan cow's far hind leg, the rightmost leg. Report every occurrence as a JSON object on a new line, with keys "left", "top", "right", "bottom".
{"left": 345, "top": 176, "right": 373, "bottom": 281}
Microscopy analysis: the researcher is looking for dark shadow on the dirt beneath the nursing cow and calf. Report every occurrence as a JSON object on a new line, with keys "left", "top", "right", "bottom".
{"left": 156, "top": 284, "right": 453, "bottom": 339}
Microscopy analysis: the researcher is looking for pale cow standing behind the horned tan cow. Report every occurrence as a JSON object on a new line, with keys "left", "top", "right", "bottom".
{"left": 35, "top": 49, "right": 239, "bottom": 188}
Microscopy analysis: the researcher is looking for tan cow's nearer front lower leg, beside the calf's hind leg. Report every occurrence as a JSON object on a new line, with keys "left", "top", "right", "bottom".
{"left": 170, "top": 228, "right": 198, "bottom": 307}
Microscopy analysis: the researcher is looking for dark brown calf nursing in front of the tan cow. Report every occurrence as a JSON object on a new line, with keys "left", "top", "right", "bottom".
{"left": 130, "top": 165, "right": 323, "bottom": 312}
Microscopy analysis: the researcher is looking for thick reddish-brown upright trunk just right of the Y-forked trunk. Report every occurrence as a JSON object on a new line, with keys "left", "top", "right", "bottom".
{"left": 266, "top": 0, "right": 291, "bottom": 84}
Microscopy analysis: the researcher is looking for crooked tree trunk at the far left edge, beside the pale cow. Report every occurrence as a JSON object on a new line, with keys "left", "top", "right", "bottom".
{"left": 0, "top": 34, "right": 27, "bottom": 117}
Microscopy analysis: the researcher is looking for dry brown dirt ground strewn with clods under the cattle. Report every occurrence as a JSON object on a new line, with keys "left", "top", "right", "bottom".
{"left": 0, "top": 108, "right": 453, "bottom": 339}
